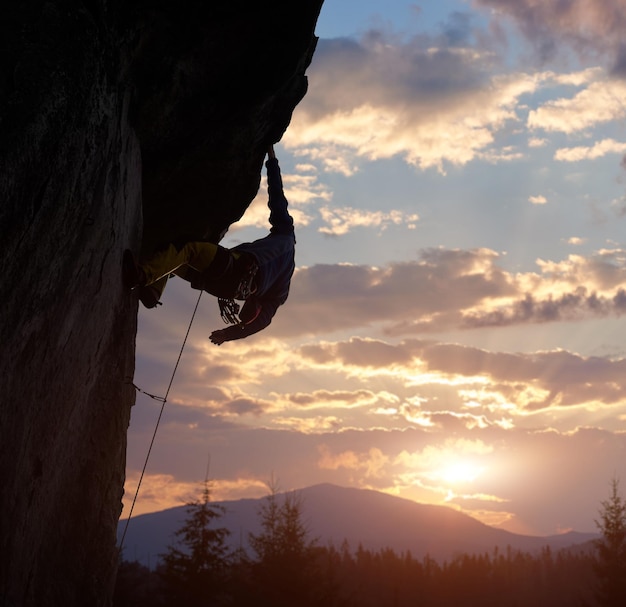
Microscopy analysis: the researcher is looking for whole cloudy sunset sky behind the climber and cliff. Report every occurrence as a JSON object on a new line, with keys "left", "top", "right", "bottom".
{"left": 122, "top": 0, "right": 626, "bottom": 535}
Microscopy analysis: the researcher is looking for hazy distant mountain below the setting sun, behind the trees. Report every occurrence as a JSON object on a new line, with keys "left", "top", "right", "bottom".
{"left": 118, "top": 484, "right": 597, "bottom": 567}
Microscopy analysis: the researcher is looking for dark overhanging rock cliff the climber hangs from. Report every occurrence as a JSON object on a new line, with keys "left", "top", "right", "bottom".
{"left": 0, "top": 0, "right": 322, "bottom": 607}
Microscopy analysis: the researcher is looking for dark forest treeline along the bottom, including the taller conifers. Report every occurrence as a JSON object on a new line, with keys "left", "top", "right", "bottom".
{"left": 113, "top": 480, "right": 626, "bottom": 607}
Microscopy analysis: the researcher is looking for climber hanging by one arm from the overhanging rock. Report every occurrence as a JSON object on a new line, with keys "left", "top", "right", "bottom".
{"left": 123, "top": 146, "right": 296, "bottom": 346}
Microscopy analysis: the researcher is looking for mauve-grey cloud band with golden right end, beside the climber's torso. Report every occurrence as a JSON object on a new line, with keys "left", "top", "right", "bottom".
{"left": 274, "top": 249, "right": 626, "bottom": 336}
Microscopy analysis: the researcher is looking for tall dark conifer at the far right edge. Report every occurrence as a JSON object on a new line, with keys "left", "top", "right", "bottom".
{"left": 595, "top": 478, "right": 626, "bottom": 607}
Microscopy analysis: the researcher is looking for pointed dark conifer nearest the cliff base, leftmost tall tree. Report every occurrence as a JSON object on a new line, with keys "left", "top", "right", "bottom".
{"left": 159, "top": 479, "right": 230, "bottom": 607}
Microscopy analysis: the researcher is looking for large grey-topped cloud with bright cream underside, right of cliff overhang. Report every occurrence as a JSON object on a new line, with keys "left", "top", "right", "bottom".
{"left": 284, "top": 35, "right": 539, "bottom": 171}
